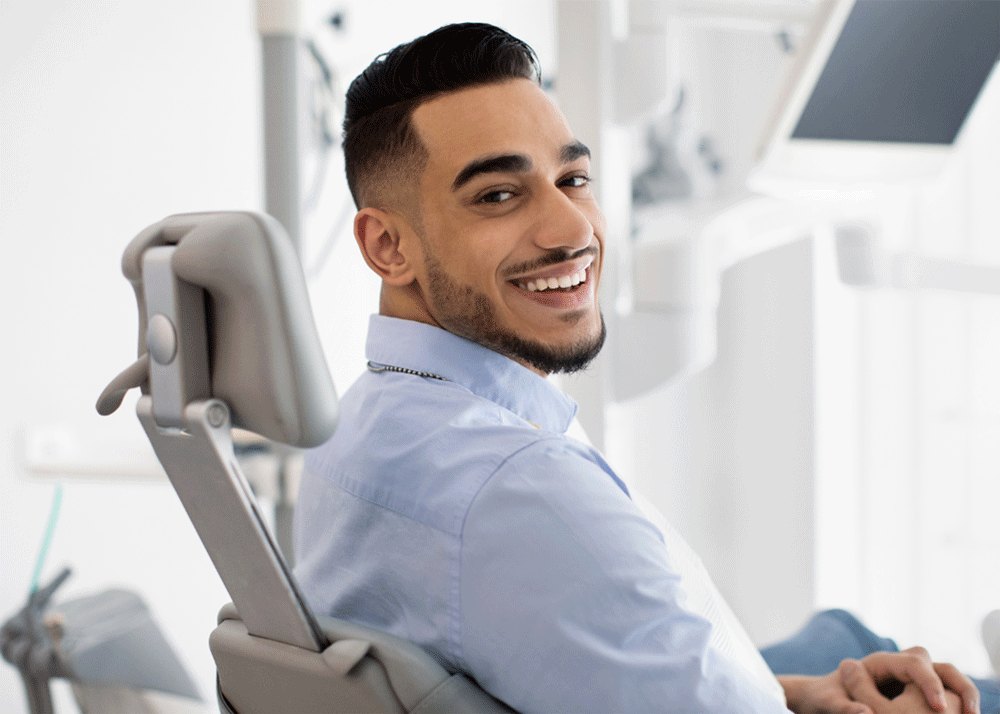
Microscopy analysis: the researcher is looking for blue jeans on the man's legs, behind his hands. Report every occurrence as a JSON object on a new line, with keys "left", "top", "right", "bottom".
{"left": 760, "top": 610, "right": 1000, "bottom": 714}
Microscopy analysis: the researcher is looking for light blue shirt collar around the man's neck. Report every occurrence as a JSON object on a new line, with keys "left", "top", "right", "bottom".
{"left": 365, "top": 315, "right": 577, "bottom": 434}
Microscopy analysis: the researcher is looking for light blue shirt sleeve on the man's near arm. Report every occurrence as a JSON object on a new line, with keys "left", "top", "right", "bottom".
{"left": 458, "top": 440, "right": 787, "bottom": 714}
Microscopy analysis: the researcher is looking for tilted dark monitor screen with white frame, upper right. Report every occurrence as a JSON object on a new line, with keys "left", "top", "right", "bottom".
{"left": 757, "top": 0, "right": 1000, "bottom": 192}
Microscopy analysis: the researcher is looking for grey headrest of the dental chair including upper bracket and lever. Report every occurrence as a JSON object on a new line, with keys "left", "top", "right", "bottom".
{"left": 98, "top": 212, "right": 337, "bottom": 446}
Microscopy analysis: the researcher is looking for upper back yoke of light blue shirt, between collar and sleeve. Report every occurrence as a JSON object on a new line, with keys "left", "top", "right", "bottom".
{"left": 306, "top": 375, "right": 568, "bottom": 532}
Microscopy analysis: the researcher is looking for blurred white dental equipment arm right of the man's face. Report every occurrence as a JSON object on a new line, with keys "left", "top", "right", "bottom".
{"left": 608, "top": 198, "right": 1000, "bottom": 401}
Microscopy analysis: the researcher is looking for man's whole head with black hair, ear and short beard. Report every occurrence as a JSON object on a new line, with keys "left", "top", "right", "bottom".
{"left": 344, "top": 24, "right": 604, "bottom": 373}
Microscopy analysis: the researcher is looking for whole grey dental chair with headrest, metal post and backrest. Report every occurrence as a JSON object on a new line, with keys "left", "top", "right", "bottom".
{"left": 97, "top": 212, "right": 511, "bottom": 714}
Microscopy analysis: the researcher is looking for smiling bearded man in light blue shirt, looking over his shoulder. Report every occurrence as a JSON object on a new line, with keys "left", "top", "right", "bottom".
{"left": 296, "top": 24, "right": 978, "bottom": 714}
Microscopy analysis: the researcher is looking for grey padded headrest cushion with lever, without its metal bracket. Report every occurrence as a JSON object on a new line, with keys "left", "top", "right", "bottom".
{"left": 97, "top": 212, "right": 337, "bottom": 447}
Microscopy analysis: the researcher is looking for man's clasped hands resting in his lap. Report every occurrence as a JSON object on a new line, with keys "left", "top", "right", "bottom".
{"left": 838, "top": 647, "right": 979, "bottom": 714}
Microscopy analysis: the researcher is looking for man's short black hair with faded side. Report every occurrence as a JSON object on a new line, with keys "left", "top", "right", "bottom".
{"left": 344, "top": 23, "right": 541, "bottom": 208}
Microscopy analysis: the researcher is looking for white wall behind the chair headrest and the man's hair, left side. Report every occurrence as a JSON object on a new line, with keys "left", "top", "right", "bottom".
{"left": 0, "top": 0, "right": 553, "bottom": 714}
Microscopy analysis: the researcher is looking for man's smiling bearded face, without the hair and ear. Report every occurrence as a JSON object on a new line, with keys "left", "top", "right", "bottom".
{"left": 402, "top": 79, "right": 604, "bottom": 373}
